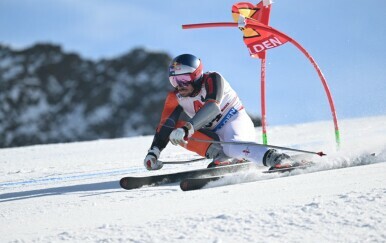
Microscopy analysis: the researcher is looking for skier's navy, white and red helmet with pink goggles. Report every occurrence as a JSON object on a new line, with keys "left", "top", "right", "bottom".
{"left": 169, "top": 54, "right": 203, "bottom": 87}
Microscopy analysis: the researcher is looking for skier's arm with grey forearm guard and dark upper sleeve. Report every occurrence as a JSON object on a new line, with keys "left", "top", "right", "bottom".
{"left": 189, "top": 72, "right": 224, "bottom": 131}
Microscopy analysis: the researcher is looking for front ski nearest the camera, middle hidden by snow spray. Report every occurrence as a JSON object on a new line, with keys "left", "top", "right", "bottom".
{"left": 180, "top": 161, "right": 314, "bottom": 191}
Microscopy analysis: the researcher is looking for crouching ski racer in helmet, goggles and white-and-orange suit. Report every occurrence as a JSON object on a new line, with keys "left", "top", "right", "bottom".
{"left": 144, "top": 54, "right": 291, "bottom": 170}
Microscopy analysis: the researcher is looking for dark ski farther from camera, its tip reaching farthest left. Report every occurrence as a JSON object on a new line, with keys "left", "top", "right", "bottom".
{"left": 119, "top": 162, "right": 257, "bottom": 190}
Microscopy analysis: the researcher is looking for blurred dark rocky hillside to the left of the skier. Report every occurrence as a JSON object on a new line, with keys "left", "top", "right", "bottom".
{"left": 0, "top": 44, "right": 171, "bottom": 147}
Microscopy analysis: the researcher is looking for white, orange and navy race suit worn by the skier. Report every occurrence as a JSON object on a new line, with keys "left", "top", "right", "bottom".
{"left": 151, "top": 72, "right": 267, "bottom": 162}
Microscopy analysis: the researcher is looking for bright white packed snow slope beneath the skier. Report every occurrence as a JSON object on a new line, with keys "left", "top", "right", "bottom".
{"left": 0, "top": 116, "right": 386, "bottom": 242}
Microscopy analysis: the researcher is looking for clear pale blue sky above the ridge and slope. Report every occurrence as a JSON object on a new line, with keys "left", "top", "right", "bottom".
{"left": 0, "top": 0, "right": 386, "bottom": 126}
